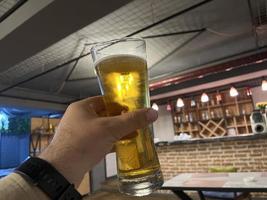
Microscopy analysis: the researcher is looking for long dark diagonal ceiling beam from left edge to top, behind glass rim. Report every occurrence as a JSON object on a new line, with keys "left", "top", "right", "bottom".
{"left": 0, "top": 0, "right": 214, "bottom": 94}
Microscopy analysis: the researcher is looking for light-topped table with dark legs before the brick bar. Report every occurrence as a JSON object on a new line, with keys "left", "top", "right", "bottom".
{"left": 161, "top": 172, "right": 267, "bottom": 200}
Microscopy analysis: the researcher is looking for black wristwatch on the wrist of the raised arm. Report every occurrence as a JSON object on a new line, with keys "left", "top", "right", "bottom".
{"left": 15, "top": 157, "right": 82, "bottom": 200}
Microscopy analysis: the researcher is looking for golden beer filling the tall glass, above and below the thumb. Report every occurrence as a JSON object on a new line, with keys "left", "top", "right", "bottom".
{"left": 95, "top": 55, "right": 159, "bottom": 177}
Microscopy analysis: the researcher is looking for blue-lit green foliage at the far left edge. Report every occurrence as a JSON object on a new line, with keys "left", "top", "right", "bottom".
{"left": 0, "top": 116, "right": 31, "bottom": 135}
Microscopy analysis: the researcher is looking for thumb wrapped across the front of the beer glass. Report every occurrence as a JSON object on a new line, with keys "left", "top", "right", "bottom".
{"left": 103, "top": 108, "right": 158, "bottom": 140}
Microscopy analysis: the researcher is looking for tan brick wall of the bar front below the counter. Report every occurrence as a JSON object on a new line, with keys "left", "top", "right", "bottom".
{"left": 157, "top": 137, "right": 267, "bottom": 180}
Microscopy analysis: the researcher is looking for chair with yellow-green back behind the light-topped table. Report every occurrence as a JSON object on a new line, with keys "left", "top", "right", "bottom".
{"left": 199, "top": 166, "right": 251, "bottom": 200}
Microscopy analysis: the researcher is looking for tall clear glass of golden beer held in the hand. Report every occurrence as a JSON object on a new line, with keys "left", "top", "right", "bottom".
{"left": 91, "top": 38, "right": 163, "bottom": 196}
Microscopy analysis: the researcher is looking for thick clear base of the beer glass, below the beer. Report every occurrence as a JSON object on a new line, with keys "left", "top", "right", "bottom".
{"left": 119, "top": 170, "right": 163, "bottom": 196}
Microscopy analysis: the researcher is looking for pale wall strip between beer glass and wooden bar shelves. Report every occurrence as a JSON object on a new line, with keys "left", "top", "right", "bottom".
{"left": 153, "top": 105, "right": 174, "bottom": 141}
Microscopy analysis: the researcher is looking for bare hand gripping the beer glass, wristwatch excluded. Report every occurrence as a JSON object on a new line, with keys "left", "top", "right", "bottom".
{"left": 40, "top": 96, "right": 158, "bottom": 187}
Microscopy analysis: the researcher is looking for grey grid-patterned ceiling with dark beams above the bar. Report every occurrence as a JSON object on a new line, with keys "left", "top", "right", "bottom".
{"left": 0, "top": 0, "right": 267, "bottom": 109}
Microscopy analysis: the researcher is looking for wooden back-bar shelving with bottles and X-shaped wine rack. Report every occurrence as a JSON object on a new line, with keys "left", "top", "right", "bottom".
{"left": 172, "top": 88, "right": 254, "bottom": 138}
